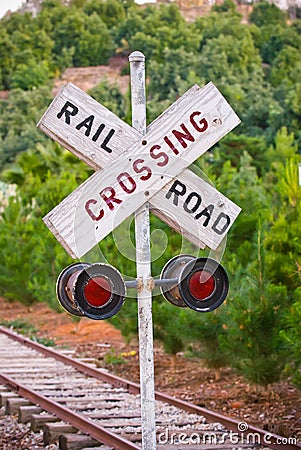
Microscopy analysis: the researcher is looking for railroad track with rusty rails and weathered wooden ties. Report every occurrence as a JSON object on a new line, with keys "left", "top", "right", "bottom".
{"left": 0, "top": 327, "right": 301, "bottom": 450}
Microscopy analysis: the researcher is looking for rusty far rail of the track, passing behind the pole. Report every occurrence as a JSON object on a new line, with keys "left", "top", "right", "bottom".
{"left": 0, "top": 326, "right": 301, "bottom": 450}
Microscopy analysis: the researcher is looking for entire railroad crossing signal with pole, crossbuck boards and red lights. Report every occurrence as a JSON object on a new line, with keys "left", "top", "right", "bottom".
{"left": 38, "top": 52, "right": 240, "bottom": 450}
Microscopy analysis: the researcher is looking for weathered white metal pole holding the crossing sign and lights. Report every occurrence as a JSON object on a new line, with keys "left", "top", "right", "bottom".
{"left": 129, "top": 51, "right": 156, "bottom": 450}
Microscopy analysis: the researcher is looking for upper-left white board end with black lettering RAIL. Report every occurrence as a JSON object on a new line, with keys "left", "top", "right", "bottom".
{"left": 37, "top": 83, "right": 140, "bottom": 169}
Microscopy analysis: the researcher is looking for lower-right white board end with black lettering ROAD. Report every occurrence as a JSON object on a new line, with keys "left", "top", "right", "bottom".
{"left": 153, "top": 169, "right": 241, "bottom": 250}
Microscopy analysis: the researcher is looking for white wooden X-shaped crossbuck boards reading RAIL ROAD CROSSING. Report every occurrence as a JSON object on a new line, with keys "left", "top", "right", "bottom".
{"left": 38, "top": 83, "right": 240, "bottom": 258}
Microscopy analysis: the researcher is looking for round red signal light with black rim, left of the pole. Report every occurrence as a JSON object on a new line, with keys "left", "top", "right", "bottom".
{"left": 57, "top": 263, "right": 126, "bottom": 320}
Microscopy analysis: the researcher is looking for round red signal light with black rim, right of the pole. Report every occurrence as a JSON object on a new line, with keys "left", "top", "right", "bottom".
{"left": 161, "top": 255, "right": 229, "bottom": 312}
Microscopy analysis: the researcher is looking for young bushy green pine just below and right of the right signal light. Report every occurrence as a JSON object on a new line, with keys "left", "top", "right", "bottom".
{"left": 223, "top": 223, "right": 288, "bottom": 386}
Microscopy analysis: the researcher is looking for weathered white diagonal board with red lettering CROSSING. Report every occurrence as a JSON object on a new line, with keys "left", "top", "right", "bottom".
{"left": 44, "top": 83, "right": 239, "bottom": 258}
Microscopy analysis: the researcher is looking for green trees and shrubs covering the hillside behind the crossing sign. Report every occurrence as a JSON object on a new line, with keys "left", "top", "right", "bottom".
{"left": 0, "top": 0, "right": 301, "bottom": 386}
